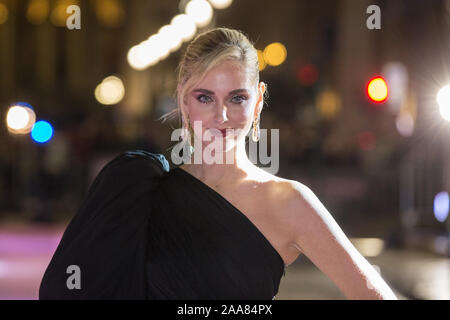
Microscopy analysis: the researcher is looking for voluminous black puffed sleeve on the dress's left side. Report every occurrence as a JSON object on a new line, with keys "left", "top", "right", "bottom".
{"left": 39, "top": 150, "right": 169, "bottom": 299}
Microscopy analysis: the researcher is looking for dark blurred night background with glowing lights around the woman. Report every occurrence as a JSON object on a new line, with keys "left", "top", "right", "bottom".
{"left": 0, "top": 0, "right": 450, "bottom": 299}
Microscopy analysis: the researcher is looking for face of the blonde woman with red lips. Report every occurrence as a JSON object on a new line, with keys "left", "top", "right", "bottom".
{"left": 182, "top": 61, "right": 265, "bottom": 150}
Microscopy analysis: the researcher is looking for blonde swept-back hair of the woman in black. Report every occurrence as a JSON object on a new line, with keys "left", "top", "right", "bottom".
{"left": 159, "top": 27, "right": 267, "bottom": 149}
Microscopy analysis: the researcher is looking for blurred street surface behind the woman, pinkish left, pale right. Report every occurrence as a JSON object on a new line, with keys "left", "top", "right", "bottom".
{"left": 0, "top": 220, "right": 450, "bottom": 300}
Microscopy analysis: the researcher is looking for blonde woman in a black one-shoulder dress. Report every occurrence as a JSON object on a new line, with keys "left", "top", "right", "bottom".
{"left": 40, "top": 28, "right": 396, "bottom": 299}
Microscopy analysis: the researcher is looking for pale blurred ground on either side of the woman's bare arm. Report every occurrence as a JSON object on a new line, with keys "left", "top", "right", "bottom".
{"left": 276, "top": 250, "right": 450, "bottom": 300}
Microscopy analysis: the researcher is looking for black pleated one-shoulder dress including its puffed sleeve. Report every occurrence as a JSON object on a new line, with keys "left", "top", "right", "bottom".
{"left": 39, "top": 150, "right": 285, "bottom": 300}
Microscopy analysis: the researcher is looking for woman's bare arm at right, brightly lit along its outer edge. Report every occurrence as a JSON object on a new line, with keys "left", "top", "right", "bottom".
{"left": 288, "top": 181, "right": 397, "bottom": 300}
